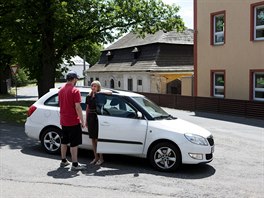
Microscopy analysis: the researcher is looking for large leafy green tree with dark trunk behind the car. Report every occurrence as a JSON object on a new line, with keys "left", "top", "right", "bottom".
{"left": 0, "top": 0, "right": 184, "bottom": 96}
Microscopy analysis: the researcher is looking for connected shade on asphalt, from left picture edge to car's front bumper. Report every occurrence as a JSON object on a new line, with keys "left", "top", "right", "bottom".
{"left": 0, "top": 123, "right": 216, "bottom": 179}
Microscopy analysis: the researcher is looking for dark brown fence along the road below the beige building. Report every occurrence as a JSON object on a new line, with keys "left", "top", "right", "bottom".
{"left": 140, "top": 92, "right": 264, "bottom": 119}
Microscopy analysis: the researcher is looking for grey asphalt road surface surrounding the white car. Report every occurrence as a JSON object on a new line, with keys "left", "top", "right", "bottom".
{"left": 0, "top": 108, "right": 264, "bottom": 198}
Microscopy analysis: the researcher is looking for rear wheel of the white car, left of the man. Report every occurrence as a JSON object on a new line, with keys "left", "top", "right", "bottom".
{"left": 41, "top": 127, "right": 61, "bottom": 154}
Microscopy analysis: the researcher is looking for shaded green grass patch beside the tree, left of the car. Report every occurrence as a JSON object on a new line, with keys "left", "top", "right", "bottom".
{"left": 0, "top": 101, "right": 34, "bottom": 125}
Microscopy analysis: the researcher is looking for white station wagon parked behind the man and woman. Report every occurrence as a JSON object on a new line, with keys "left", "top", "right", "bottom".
{"left": 25, "top": 87, "right": 214, "bottom": 171}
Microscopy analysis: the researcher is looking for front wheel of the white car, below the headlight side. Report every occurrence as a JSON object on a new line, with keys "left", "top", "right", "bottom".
{"left": 149, "top": 142, "right": 181, "bottom": 172}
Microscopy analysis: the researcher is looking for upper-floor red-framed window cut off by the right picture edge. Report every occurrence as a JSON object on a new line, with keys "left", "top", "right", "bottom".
{"left": 251, "top": 2, "right": 264, "bottom": 40}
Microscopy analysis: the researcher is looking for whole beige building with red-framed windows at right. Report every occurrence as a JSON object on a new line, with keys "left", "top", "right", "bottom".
{"left": 194, "top": 0, "right": 264, "bottom": 101}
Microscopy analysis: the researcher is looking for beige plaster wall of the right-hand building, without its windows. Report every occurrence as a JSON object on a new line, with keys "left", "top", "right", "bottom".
{"left": 197, "top": 0, "right": 264, "bottom": 100}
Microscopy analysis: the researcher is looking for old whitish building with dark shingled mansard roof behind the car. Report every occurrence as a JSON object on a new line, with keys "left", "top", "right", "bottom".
{"left": 86, "top": 30, "right": 193, "bottom": 94}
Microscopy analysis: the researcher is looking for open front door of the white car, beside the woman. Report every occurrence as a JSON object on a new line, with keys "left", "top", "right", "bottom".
{"left": 96, "top": 93, "right": 147, "bottom": 154}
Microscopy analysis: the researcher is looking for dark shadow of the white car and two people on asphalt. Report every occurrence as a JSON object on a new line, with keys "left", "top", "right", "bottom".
{"left": 21, "top": 145, "right": 216, "bottom": 179}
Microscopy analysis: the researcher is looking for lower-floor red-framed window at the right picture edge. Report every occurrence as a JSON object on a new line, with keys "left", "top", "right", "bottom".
{"left": 253, "top": 72, "right": 264, "bottom": 101}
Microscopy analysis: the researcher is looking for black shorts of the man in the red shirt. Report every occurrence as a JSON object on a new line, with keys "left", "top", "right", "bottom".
{"left": 61, "top": 124, "right": 82, "bottom": 147}
